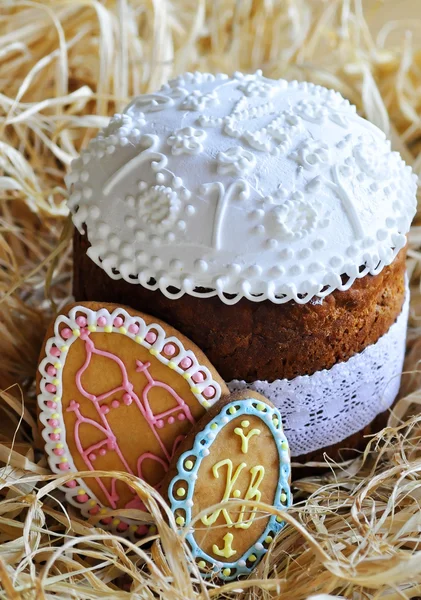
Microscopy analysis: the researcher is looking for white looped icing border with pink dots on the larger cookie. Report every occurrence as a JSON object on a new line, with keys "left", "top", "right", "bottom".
{"left": 37, "top": 305, "right": 222, "bottom": 540}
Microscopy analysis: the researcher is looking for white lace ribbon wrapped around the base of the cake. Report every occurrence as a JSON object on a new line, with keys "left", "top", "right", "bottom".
{"left": 228, "top": 289, "right": 409, "bottom": 456}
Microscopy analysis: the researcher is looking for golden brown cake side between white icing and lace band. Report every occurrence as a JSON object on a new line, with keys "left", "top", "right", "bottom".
{"left": 74, "top": 232, "right": 406, "bottom": 382}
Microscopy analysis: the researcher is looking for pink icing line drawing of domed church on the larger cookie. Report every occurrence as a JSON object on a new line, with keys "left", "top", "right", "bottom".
{"left": 67, "top": 330, "right": 194, "bottom": 508}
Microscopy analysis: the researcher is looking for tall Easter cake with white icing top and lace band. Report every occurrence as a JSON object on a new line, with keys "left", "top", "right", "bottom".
{"left": 67, "top": 72, "right": 416, "bottom": 460}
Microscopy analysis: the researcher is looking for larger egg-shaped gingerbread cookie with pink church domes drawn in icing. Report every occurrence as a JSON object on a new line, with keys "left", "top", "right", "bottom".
{"left": 38, "top": 302, "right": 227, "bottom": 535}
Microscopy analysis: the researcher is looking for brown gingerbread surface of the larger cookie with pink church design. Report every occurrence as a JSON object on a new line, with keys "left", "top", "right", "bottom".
{"left": 38, "top": 302, "right": 227, "bottom": 508}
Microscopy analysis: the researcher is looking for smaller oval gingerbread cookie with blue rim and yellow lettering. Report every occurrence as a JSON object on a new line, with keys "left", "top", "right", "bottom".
{"left": 163, "top": 391, "right": 291, "bottom": 580}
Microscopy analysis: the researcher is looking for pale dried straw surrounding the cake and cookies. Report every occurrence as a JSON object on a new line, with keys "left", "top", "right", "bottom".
{"left": 0, "top": 0, "right": 421, "bottom": 600}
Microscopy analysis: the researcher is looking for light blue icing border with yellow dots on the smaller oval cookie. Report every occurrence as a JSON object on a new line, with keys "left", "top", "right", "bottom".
{"left": 168, "top": 397, "right": 292, "bottom": 581}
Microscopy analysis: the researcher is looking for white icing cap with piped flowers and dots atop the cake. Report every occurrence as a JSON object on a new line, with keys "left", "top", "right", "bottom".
{"left": 67, "top": 72, "right": 416, "bottom": 304}
